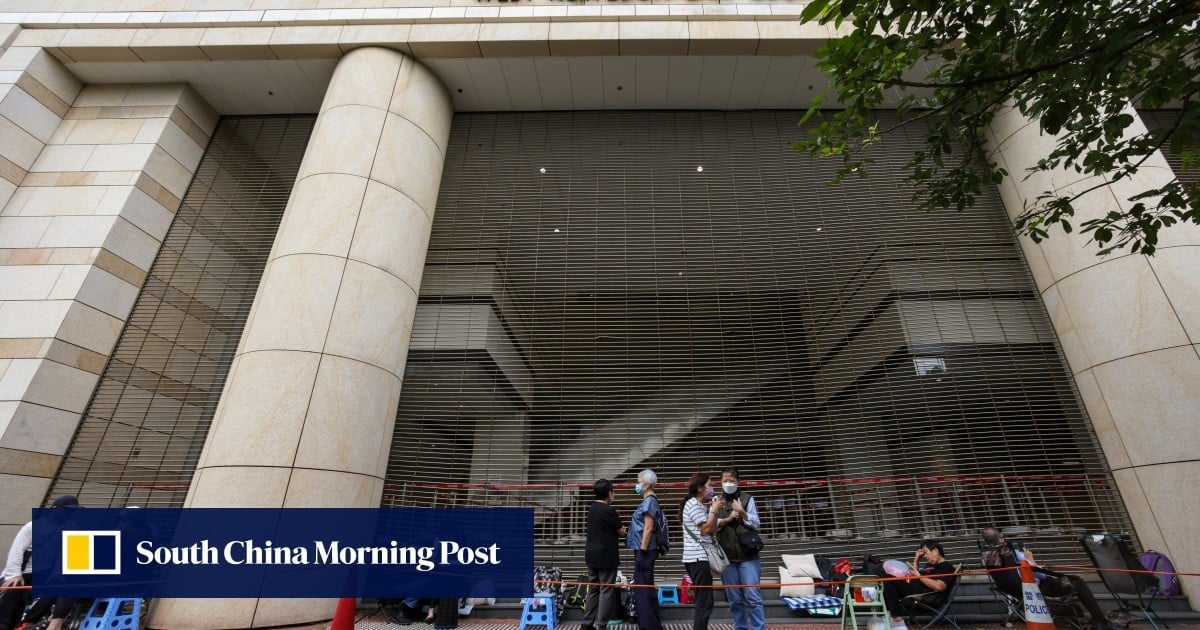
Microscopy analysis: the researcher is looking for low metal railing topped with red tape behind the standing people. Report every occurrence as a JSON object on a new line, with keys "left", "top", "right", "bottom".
{"left": 126, "top": 473, "right": 1124, "bottom": 547}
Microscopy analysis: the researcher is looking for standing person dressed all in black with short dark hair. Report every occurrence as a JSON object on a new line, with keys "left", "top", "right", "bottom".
{"left": 580, "top": 479, "right": 625, "bottom": 630}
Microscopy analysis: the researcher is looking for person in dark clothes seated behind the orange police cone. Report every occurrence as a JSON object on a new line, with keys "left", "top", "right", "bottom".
{"left": 979, "top": 527, "right": 1116, "bottom": 630}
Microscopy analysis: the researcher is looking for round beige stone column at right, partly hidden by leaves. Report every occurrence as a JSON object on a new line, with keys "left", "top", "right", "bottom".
{"left": 990, "top": 105, "right": 1200, "bottom": 607}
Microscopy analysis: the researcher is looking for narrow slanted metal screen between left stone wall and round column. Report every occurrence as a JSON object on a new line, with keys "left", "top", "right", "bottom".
{"left": 50, "top": 115, "right": 316, "bottom": 506}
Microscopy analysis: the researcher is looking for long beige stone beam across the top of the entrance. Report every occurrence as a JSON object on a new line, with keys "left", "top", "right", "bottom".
{"left": 0, "top": 6, "right": 838, "bottom": 62}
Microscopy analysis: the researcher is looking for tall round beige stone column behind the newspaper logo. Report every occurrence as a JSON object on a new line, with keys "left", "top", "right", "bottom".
{"left": 150, "top": 48, "right": 454, "bottom": 629}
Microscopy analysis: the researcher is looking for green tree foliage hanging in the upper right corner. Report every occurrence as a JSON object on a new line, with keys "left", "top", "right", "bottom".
{"left": 793, "top": 0, "right": 1200, "bottom": 254}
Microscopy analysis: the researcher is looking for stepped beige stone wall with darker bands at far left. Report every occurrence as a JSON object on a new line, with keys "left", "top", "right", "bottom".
{"left": 0, "top": 60, "right": 217, "bottom": 542}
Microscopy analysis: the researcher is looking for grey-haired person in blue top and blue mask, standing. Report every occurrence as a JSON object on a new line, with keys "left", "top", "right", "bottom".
{"left": 625, "top": 468, "right": 667, "bottom": 630}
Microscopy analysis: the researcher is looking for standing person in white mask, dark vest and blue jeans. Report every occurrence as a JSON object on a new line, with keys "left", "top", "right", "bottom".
{"left": 713, "top": 468, "right": 767, "bottom": 630}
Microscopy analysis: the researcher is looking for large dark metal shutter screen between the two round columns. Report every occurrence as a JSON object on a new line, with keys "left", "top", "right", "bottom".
{"left": 383, "top": 112, "right": 1129, "bottom": 575}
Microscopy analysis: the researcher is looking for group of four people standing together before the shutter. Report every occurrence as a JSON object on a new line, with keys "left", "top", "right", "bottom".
{"left": 581, "top": 468, "right": 767, "bottom": 630}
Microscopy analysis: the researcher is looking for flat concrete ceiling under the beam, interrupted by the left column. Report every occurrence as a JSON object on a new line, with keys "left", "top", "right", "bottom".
{"left": 67, "top": 55, "right": 824, "bottom": 115}
